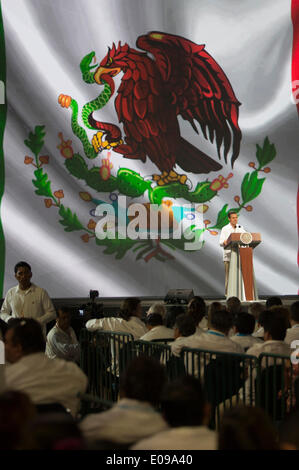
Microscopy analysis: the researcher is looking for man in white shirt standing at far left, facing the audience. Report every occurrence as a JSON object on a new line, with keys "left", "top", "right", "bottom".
{"left": 0, "top": 261, "right": 56, "bottom": 334}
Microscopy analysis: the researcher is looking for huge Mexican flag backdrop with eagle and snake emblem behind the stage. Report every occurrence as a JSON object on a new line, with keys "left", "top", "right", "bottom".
{"left": 0, "top": 0, "right": 299, "bottom": 297}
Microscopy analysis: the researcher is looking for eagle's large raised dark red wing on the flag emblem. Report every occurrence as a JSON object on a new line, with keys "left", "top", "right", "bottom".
{"left": 136, "top": 32, "right": 242, "bottom": 166}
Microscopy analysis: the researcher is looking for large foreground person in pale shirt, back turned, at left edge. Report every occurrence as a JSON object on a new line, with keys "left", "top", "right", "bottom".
{"left": 5, "top": 318, "right": 87, "bottom": 415}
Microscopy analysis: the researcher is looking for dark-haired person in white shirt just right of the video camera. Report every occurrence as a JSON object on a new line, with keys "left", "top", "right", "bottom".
{"left": 85, "top": 297, "right": 147, "bottom": 339}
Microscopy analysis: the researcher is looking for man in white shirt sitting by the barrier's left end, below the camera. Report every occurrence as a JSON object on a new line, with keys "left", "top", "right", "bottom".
{"left": 46, "top": 307, "right": 80, "bottom": 362}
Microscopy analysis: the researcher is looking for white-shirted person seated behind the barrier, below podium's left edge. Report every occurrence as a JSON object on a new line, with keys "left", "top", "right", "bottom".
{"left": 191, "top": 310, "right": 244, "bottom": 354}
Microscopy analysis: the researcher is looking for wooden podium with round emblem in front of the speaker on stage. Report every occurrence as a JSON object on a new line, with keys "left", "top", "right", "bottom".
{"left": 225, "top": 232, "right": 261, "bottom": 301}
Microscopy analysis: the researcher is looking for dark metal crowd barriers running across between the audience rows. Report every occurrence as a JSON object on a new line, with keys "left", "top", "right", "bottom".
{"left": 80, "top": 329, "right": 298, "bottom": 427}
